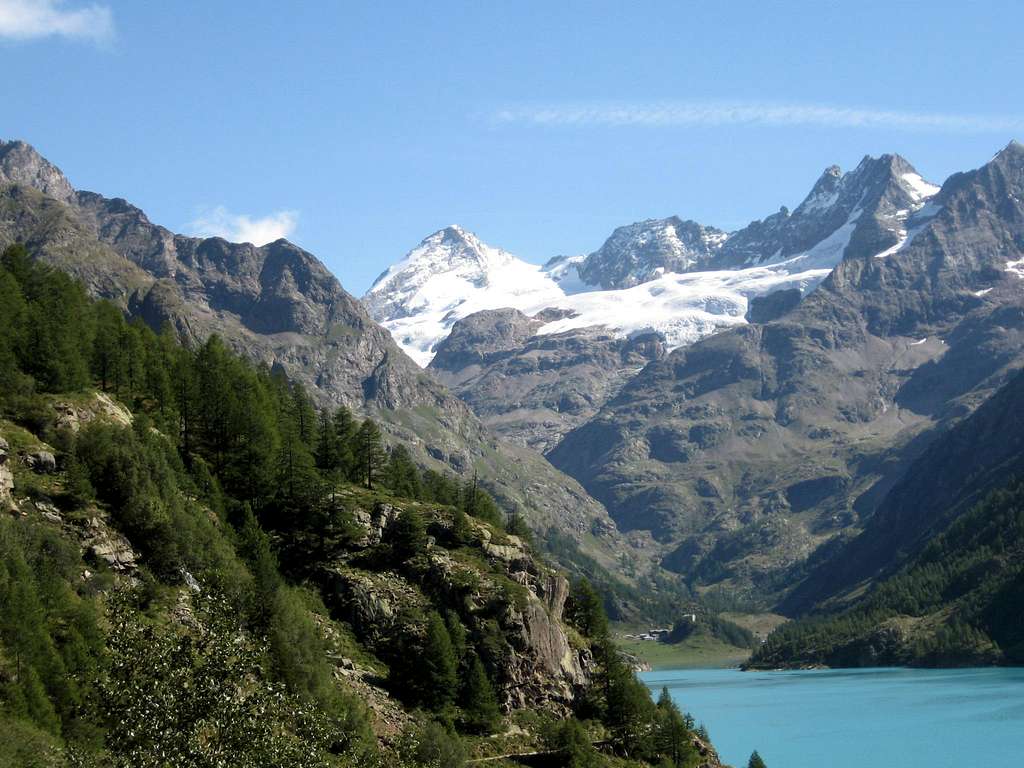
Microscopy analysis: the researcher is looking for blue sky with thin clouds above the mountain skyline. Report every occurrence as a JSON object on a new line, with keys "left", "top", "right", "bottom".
{"left": 0, "top": 0, "right": 1024, "bottom": 294}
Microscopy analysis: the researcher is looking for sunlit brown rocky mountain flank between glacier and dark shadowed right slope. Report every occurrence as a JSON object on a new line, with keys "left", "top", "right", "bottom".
{"left": 549, "top": 140, "right": 1024, "bottom": 594}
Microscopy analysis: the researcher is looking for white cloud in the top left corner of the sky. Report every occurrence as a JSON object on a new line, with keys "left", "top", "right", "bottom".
{"left": 0, "top": 0, "right": 114, "bottom": 43}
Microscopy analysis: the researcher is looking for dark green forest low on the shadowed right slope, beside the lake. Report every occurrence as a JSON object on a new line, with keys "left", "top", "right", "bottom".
{"left": 751, "top": 480, "right": 1024, "bottom": 667}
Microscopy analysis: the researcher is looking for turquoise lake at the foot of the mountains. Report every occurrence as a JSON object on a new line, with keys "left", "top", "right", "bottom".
{"left": 640, "top": 669, "right": 1024, "bottom": 768}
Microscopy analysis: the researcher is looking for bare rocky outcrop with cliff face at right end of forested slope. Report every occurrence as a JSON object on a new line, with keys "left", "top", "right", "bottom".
{"left": 319, "top": 503, "right": 590, "bottom": 712}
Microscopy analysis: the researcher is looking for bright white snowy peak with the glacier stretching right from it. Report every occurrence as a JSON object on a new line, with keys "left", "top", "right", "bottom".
{"left": 364, "top": 226, "right": 828, "bottom": 367}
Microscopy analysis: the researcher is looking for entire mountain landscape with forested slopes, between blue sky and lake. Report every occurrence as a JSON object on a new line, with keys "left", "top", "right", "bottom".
{"left": 0, "top": 134, "right": 1024, "bottom": 768}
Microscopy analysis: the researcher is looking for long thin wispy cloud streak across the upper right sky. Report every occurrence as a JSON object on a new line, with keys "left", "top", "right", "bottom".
{"left": 487, "top": 101, "right": 1024, "bottom": 133}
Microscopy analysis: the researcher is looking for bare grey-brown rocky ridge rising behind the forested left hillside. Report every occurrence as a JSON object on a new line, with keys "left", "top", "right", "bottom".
{"left": 0, "top": 141, "right": 649, "bottom": 604}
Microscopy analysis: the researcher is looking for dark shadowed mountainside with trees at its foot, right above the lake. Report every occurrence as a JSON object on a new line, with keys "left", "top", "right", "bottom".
{"left": 752, "top": 374, "right": 1024, "bottom": 667}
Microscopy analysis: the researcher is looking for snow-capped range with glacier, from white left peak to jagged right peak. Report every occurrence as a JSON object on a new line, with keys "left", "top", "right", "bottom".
{"left": 364, "top": 155, "right": 938, "bottom": 366}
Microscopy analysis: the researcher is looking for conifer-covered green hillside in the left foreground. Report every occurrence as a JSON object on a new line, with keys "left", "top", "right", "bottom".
{"left": 0, "top": 246, "right": 729, "bottom": 768}
